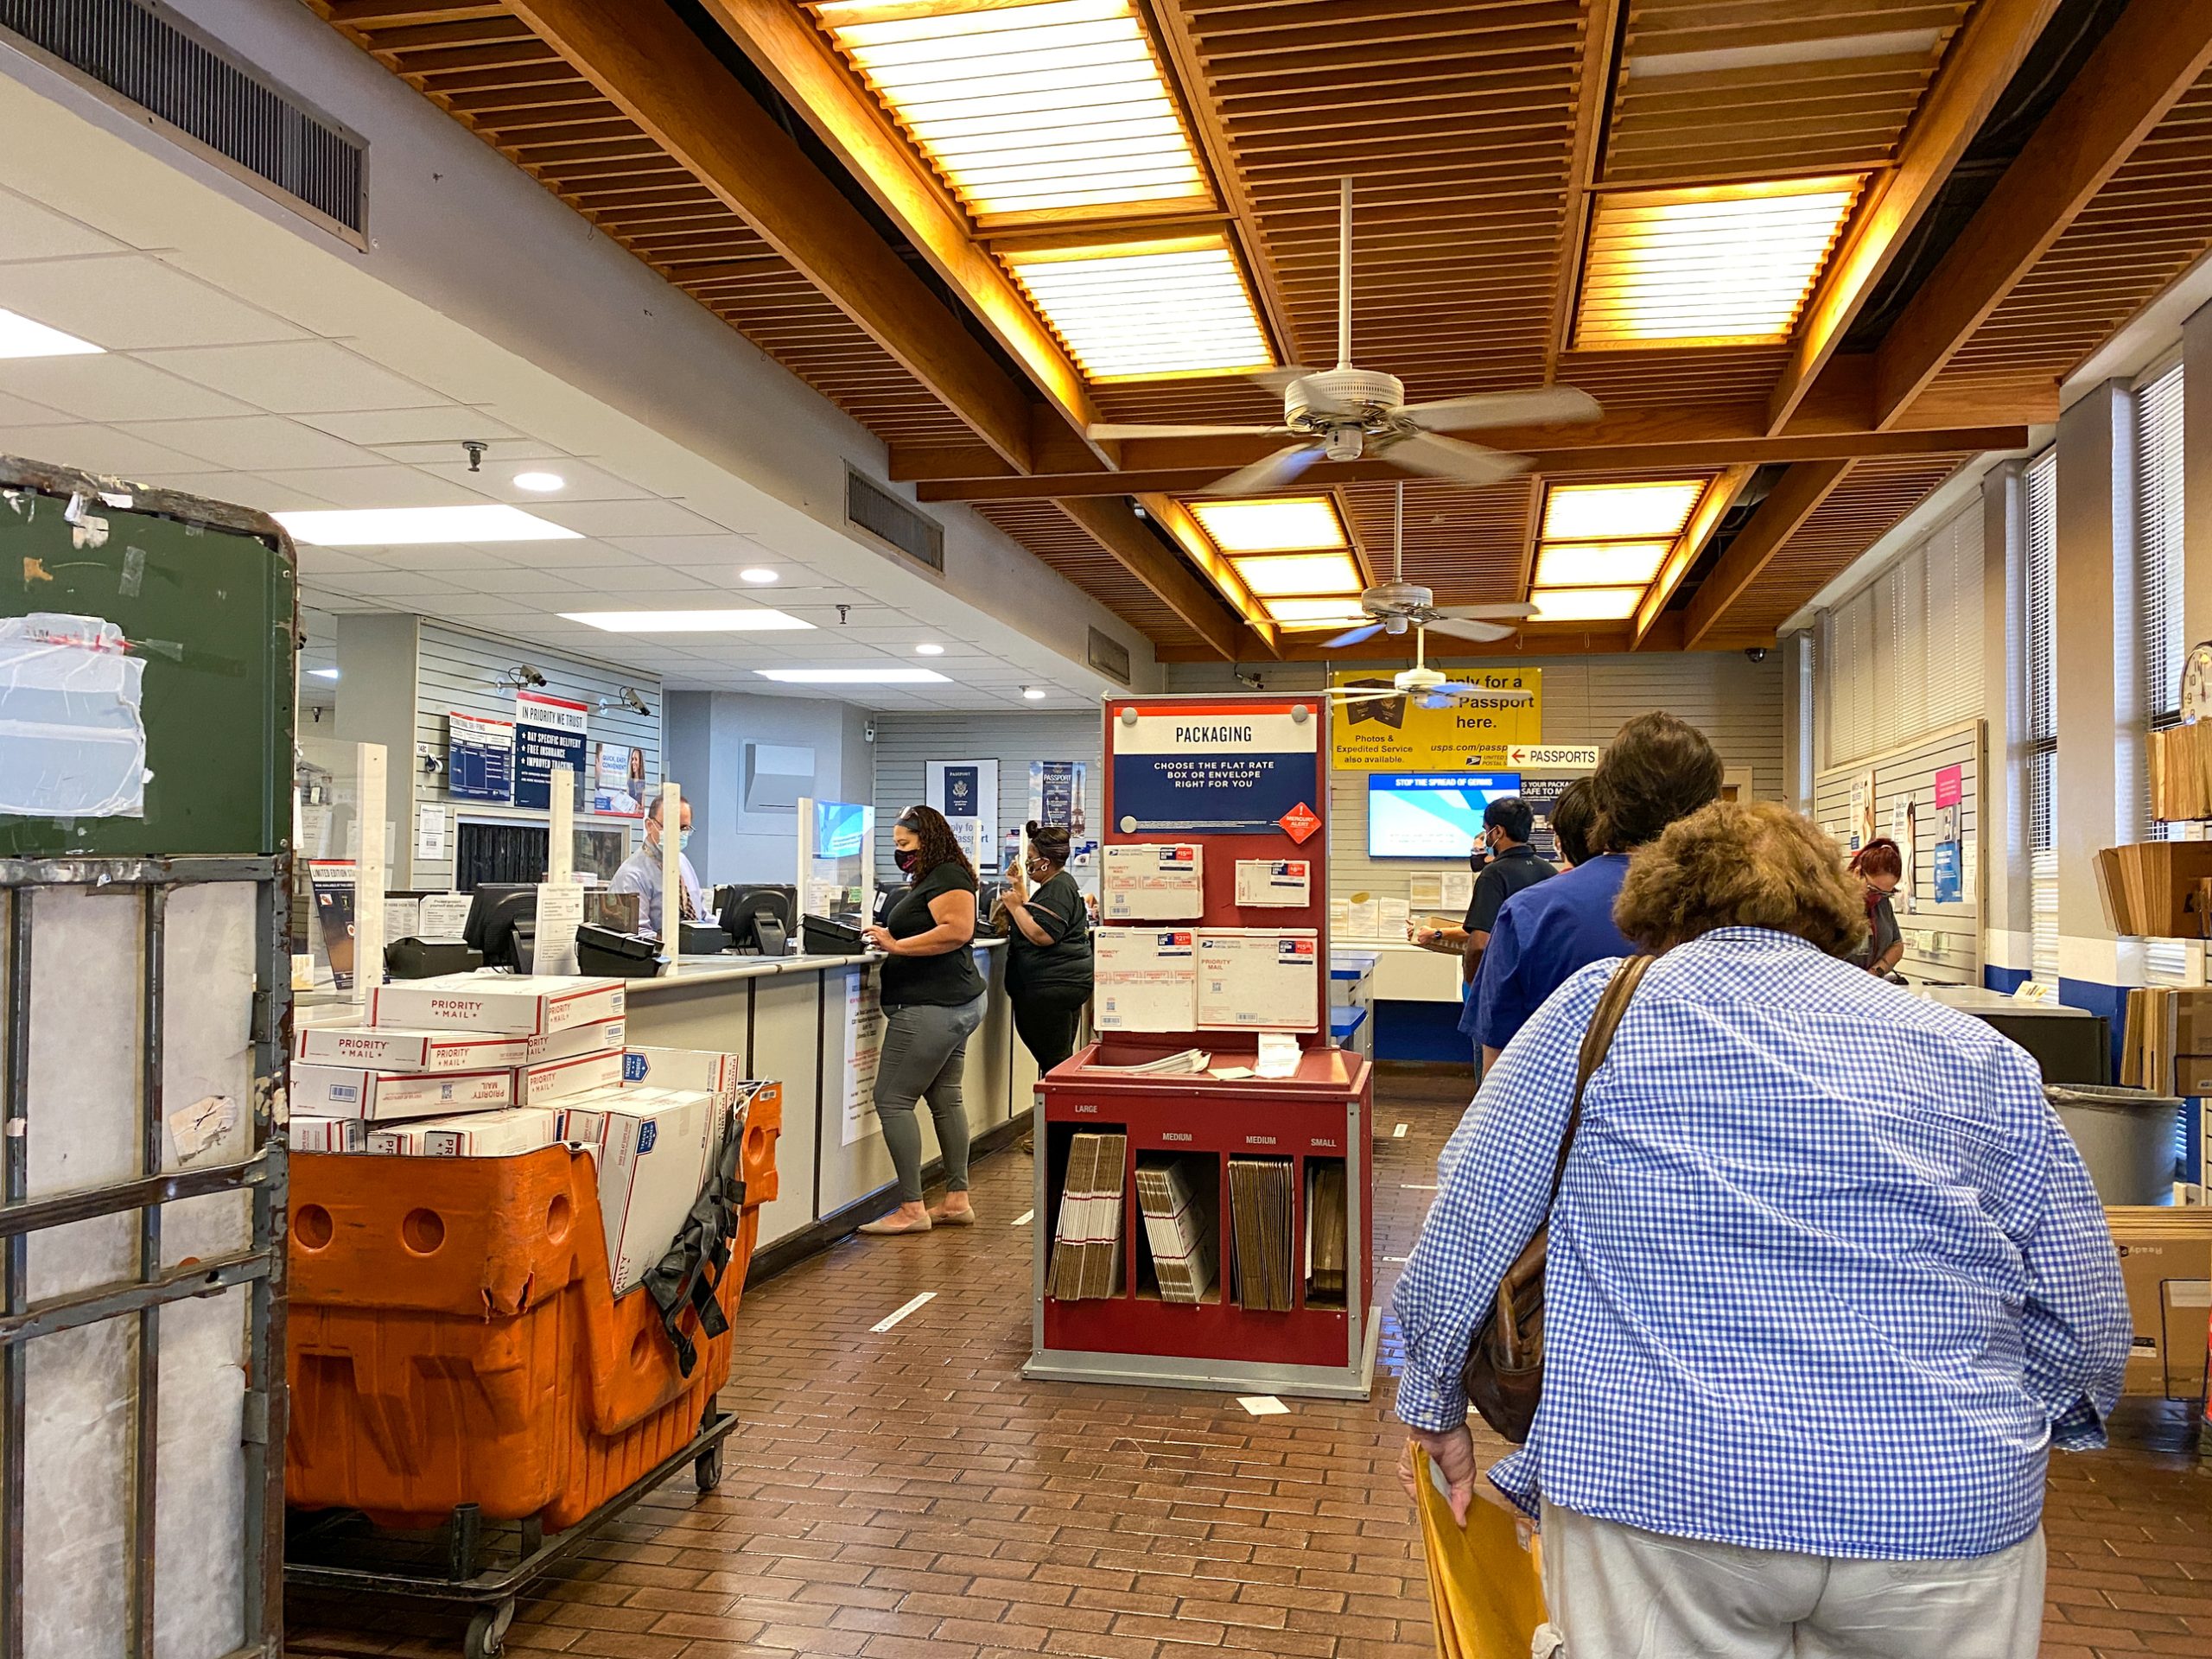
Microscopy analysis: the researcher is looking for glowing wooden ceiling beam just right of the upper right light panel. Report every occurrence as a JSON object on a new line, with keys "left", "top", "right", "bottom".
{"left": 1767, "top": 0, "right": 2057, "bottom": 431}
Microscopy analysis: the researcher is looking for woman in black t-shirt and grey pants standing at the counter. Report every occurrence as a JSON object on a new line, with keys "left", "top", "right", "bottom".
{"left": 861, "top": 807, "right": 984, "bottom": 1234}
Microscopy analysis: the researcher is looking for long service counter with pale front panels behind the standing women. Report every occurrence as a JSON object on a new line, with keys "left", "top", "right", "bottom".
{"left": 628, "top": 940, "right": 1038, "bottom": 1276}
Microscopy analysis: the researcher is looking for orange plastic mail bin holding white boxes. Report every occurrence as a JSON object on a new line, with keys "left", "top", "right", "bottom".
{"left": 285, "top": 1084, "right": 783, "bottom": 1531}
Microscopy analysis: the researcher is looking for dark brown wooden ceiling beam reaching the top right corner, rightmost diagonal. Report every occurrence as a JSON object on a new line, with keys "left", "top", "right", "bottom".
{"left": 1873, "top": 0, "right": 2212, "bottom": 427}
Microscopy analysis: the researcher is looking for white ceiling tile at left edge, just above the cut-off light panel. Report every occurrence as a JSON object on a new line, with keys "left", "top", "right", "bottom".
{"left": 0, "top": 254, "right": 305, "bottom": 352}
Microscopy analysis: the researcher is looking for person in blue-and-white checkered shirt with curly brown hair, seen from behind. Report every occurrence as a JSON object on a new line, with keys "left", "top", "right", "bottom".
{"left": 1394, "top": 803, "right": 2130, "bottom": 1659}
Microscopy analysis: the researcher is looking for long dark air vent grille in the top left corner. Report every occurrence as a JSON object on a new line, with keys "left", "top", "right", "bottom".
{"left": 0, "top": 0, "right": 367, "bottom": 237}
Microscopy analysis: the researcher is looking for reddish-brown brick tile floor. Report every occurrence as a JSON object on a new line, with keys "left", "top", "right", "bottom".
{"left": 285, "top": 1102, "right": 2212, "bottom": 1659}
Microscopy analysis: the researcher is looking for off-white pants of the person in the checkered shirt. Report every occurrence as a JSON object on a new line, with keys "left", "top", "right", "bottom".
{"left": 1535, "top": 1504, "right": 2044, "bottom": 1659}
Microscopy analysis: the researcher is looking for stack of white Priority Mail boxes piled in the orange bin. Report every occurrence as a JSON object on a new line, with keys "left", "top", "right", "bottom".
{"left": 289, "top": 973, "right": 774, "bottom": 1296}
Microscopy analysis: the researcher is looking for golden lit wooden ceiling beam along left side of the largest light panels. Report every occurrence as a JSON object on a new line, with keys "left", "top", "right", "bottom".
{"left": 706, "top": 0, "right": 1115, "bottom": 467}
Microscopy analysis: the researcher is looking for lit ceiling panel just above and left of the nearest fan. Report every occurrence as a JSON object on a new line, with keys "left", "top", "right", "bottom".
{"left": 1007, "top": 234, "right": 1274, "bottom": 380}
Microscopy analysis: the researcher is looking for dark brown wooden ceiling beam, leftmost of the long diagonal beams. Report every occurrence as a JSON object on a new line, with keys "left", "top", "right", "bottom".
{"left": 513, "top": 0, "right": 1031, "bottom": 469}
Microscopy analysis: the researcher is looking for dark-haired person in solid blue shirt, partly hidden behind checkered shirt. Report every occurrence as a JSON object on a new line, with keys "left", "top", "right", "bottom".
{"left": 1460, "top": 710, "right": 1721, "bottom": 1071}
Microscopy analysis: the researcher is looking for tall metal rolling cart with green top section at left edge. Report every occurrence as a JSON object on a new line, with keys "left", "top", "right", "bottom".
{"left": 0, "top": 458, "right": 296, "bottom": 1659}
